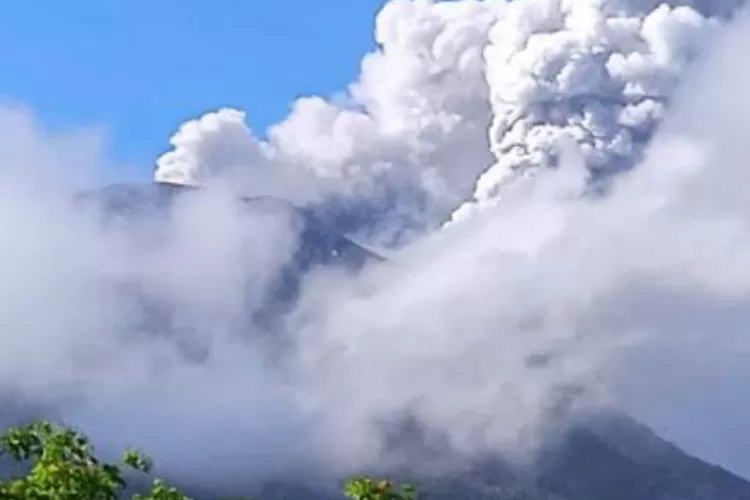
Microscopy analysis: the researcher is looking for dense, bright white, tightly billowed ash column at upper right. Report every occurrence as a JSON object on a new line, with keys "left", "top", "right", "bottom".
{"left": 454, "top": 0, "right": 719, "bottom": 218}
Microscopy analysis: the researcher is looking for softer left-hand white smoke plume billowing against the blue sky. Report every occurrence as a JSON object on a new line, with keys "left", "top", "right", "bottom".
{"left": 156, "top": 0, "right": 497, "bottom": 243}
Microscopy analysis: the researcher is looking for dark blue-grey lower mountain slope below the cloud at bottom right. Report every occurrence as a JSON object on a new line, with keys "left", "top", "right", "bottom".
{"left": 245, "top": 414, "right": 750, "bottom": 500}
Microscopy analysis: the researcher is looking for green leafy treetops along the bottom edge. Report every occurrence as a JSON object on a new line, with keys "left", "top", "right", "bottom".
{"left": 0, "top": 421, "right": 416, "bottom": 500}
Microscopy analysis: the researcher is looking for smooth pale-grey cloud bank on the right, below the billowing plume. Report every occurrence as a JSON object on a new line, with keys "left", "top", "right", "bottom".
{"left": 278, "top": 8, "right": 750, "bottom": 471}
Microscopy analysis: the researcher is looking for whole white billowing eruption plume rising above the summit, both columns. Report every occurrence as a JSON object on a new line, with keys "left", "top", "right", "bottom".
{"left": 156, "top": 0, "right": 739, "bottom": 240}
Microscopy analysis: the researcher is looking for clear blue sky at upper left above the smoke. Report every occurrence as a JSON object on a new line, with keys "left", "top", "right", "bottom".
{"left": 0, "top": 0, "right": 383, "bottom": 184}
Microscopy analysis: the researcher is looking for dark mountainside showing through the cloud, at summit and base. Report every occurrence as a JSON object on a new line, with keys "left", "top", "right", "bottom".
{"left": 0, "top": 184, "right": 750, "bottom": 500}
